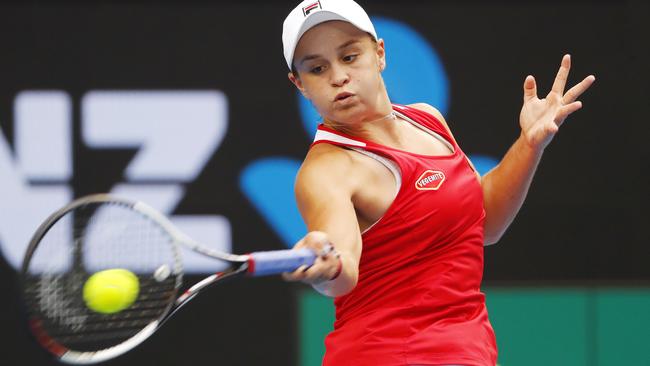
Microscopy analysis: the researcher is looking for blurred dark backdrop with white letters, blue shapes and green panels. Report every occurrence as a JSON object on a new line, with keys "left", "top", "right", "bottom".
{"left": 0, "top": 0, "right": 650, "bottom": 366}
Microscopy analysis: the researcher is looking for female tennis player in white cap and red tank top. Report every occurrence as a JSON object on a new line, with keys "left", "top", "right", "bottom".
{"left": 282, "top": 0, "right": 595, "bottom": 366}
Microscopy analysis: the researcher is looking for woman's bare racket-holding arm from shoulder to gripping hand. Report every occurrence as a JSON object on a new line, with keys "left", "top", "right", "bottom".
{"left": 284, "top": 144, "right": 361, "bottom": 297}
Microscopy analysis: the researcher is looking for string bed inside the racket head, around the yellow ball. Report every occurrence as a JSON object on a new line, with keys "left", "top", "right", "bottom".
{"left": 23, "top": 204, "right": 182, "bottom": 352}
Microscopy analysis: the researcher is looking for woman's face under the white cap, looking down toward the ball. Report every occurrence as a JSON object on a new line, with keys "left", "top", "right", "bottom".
{"left": 289, "top": 21, "right": 388, "bottom": 124}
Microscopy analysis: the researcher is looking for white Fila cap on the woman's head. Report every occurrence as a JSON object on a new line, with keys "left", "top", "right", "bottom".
{"left": 282, "top": 0, "right": 377, "bottom": 69}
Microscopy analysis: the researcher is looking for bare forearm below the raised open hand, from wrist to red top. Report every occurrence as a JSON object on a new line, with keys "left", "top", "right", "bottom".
{"left": 481, "top": 136, "right": 542, "bottom": 245}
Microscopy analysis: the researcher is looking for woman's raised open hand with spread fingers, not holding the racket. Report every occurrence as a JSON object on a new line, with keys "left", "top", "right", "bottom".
{"left": 519, "top": 55, "right": 596, "bottom": 152}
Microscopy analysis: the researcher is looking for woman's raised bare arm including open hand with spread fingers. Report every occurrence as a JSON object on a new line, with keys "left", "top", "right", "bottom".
{"left": 481, "top": 55, "right": 596, "bottom": 245}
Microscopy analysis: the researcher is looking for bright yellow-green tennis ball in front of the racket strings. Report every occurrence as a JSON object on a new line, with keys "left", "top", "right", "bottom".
{"left": 83, "top": 268, "right": 140, "bottom": 314}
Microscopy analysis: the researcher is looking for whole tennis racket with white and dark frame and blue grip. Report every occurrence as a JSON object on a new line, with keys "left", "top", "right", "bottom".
{"left": 21, "top": 194, "right": 316, "bottom": 364}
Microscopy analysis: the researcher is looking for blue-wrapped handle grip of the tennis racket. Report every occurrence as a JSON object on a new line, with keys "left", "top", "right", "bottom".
{"left": 248, "top": 248, "right": 316, "bottom": 277}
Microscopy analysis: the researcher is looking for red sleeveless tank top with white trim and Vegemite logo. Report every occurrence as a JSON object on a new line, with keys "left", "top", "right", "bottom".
{"left": 314, "top": 105, "right": 497, "bottom": 366}
